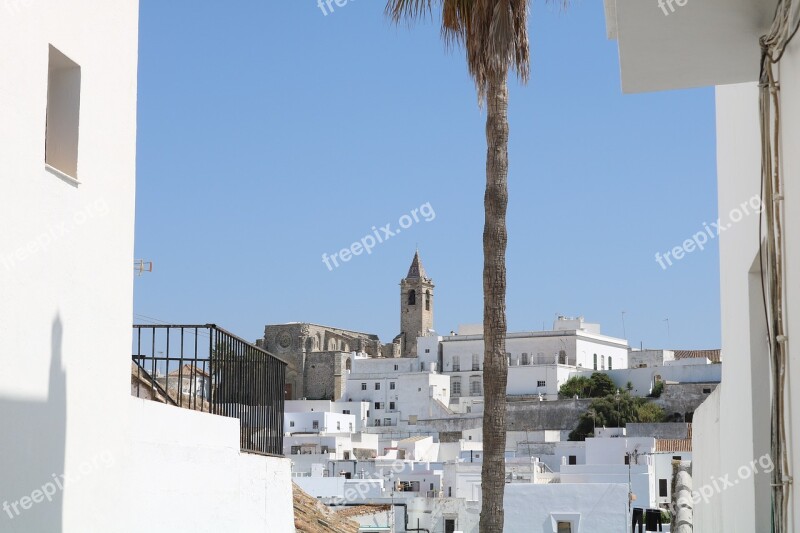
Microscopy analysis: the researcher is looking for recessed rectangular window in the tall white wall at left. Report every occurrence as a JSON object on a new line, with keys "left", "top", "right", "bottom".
{"left": 44, "top": 46, "right": 81, "bottom": 180}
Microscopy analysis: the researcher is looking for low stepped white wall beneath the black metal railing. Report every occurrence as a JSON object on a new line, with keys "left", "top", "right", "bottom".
{"left": 128, "top": 398, "right": 294, "bottom": 533}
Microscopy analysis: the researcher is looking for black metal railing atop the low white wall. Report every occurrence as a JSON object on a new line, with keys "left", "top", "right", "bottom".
{"left": 131, "top": 324, "right": 286, "bottom": 455}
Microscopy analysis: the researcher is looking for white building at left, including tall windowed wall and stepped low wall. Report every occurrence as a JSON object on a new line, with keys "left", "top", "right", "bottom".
{"left": 0, "top": 0, "right": 293, "bottom": 533}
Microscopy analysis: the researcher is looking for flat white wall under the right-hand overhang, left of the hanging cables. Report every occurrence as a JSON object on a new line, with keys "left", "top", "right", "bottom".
{"left": 693, "top": 80, "right": 776, "bottom": 532}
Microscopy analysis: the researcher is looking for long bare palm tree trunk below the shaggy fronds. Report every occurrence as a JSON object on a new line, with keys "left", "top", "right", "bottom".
{"left": 480, "top": 75, "right": 508, "bottom": 533}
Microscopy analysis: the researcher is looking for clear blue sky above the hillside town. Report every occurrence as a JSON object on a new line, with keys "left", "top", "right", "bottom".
{"left": 134, "top": 0, "right": 719, "bottom": 349}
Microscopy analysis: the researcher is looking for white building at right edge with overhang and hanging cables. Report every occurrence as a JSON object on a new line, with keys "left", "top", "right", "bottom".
{"left": 606, "top": 0, "right": 800, "bottom": 533}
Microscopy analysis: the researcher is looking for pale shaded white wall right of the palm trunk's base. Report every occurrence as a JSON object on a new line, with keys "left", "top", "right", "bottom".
{"left": 503, "top": 483, "right": 629, "bottom": 533}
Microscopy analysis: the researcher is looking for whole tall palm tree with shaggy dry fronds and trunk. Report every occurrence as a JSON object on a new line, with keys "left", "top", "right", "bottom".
{"left": 386, "top": 0, "right": 530, "bottom": 533}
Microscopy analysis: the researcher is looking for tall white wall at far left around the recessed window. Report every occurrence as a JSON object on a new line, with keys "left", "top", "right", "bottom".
{"left": 0, "top": 0, "right": 138, "bottom": 532}
